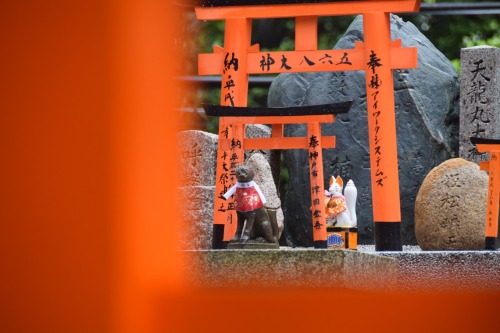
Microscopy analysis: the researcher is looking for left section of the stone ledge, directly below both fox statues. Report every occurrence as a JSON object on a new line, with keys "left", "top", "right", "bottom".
{"left": 180, "top": 248, "right": 397, "bottom": 291}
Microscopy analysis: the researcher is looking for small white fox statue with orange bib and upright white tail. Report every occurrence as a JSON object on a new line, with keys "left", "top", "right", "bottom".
{"left": 325, "top": 176, "right": 358, "bottom": 227}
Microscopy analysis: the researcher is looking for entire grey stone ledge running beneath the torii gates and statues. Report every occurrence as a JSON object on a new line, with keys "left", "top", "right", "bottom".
{"left": 179, "top": 245, "right": 500, "bottom": 292}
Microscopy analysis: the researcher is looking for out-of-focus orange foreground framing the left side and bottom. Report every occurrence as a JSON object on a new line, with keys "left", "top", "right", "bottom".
{"left": 0, "top": 0, "right": 499, "bottom": 333}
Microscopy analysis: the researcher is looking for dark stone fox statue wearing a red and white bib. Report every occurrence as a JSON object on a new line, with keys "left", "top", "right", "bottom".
{"left": 224, "top": 165, "right": 278, "bottom": 243}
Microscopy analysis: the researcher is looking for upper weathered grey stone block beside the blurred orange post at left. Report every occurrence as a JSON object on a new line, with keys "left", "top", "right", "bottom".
{"left": 177, "top": 130, "right": 218, "bottom": 187}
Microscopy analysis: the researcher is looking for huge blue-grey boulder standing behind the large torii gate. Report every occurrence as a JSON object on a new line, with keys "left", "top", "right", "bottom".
{"left": 268, "top": 15, "right": 459, "bottom": 246}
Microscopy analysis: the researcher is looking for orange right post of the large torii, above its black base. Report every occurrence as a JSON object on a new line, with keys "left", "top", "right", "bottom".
{"left": 363, "top": 12, "right": 401, "bottom": 222}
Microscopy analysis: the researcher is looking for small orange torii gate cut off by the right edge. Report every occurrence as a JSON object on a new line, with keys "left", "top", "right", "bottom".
{"left": 470, "top": 138, "right": 500, "bottom": 250}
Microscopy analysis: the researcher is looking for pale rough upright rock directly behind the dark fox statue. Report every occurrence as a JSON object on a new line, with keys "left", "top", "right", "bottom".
{"left": 246, "top": 153, "right": 285, "bottom": 236}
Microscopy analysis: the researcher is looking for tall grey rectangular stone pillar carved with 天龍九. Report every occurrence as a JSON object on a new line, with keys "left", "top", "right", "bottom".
{"left": 459, "top": 46, "right": 500, "bottom": 163}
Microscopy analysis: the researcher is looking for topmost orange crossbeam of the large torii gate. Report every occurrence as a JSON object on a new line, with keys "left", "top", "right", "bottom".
{"left": 195, "top": 0, "right": 421, "bottom": 20}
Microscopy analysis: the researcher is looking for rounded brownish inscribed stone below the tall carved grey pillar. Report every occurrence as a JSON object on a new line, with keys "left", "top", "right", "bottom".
{"left": 415, "top": 158, "right": 488, "bottom": 250}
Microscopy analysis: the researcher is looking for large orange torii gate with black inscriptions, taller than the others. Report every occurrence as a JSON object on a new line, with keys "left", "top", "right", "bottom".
{"left": 195, "top": 0, "right": 420, "bottom": 251}
